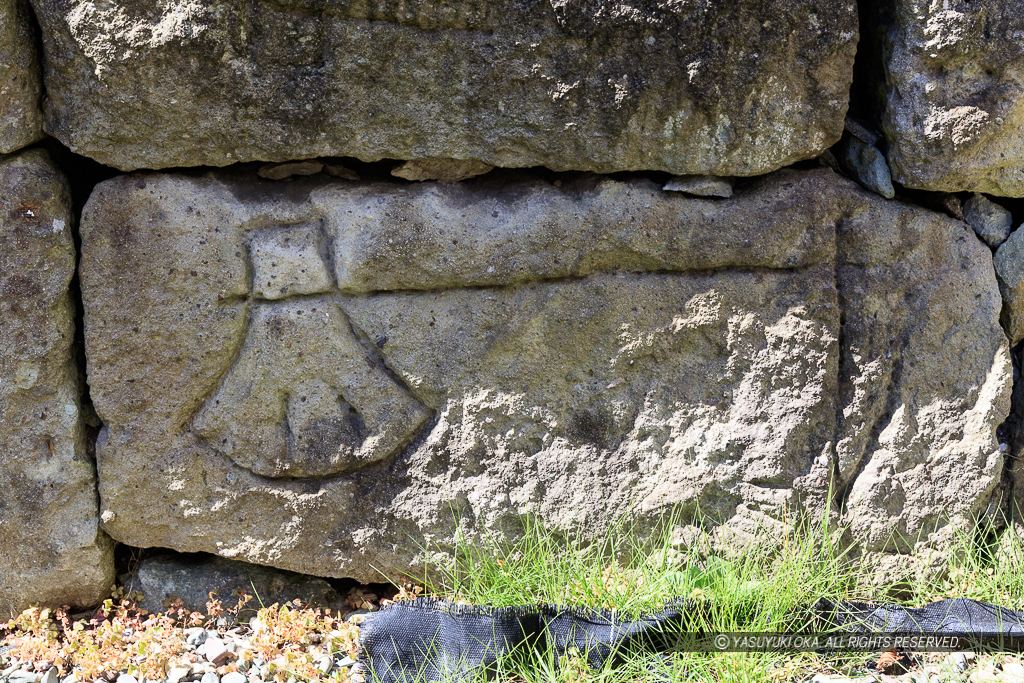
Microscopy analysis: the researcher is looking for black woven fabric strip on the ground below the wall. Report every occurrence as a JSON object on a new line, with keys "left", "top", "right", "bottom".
{"left": 359, "top": 598, "right": 1024, "bottom": 683}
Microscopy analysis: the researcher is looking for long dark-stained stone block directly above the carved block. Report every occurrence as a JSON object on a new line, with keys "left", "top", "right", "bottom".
{"left": 33, "top": 0, "right": 857, "bottom": 175}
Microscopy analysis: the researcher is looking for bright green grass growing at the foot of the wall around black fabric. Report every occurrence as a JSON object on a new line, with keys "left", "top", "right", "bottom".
{"left": 385, "top": 507, "right": 1024, "bottom": 683}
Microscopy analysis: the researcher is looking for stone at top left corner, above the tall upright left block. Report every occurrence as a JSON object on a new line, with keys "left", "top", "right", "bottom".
{"left": 0, "top": 0, "right": 43, "bottom": 154}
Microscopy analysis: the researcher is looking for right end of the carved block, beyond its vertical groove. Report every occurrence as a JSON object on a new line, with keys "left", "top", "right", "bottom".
{"left": 836, "top": 187, "right": 1013, "bottom": 555}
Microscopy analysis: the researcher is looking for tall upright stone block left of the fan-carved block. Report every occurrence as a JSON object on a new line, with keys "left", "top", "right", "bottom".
{"left": 0, "top": 152, "right": 114, "bottom": 618}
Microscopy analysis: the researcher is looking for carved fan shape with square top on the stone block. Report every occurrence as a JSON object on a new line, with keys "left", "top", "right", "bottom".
{"left": 193, "top": 224, "right": 430, "bottom": 477}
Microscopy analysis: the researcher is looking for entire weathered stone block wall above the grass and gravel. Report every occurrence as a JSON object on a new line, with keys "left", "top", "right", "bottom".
{"left": 0, "top": 0, "right": 1024, "bottom": 612}
